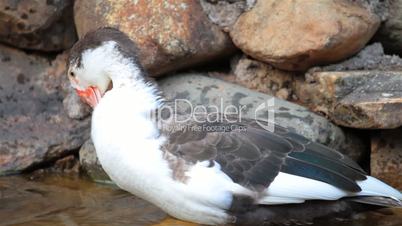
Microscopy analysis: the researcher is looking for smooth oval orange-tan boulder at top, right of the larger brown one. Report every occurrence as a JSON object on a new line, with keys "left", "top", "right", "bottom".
{"left": 230, "top": 0, "right": 380, "bottom": 70}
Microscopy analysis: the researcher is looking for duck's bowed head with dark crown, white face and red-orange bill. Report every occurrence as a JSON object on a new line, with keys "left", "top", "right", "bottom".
{"left": 67, "top": 27, "right": 144, "bottom": 107}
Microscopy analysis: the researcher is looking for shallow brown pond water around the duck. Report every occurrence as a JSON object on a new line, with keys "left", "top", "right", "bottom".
{"left": 0, "top": 174, "right": 402, "bottom": 226}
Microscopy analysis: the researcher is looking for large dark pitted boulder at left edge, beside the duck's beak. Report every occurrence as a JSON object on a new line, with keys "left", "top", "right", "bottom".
{"left": 0, "top": 46, "right": 89, "bottom": 175}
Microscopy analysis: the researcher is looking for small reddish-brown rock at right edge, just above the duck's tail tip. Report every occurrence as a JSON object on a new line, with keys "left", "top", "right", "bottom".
{"left": 371, "top": 129, "right": 402, "bottom": 190}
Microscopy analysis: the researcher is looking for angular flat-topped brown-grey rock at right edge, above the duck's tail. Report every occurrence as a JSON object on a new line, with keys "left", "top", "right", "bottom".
{"left": 295, "top": 70, "right": 402, "bottom": 129}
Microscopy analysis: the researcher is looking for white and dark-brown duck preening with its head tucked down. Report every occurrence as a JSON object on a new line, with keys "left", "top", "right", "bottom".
{"left": 67, "top": 27, "right": 402, "bottom": 225}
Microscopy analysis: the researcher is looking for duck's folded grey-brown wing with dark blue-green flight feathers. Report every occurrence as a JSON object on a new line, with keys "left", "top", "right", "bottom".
{"left": 161, "top": 115, "right": 366, "bottom": 192}
